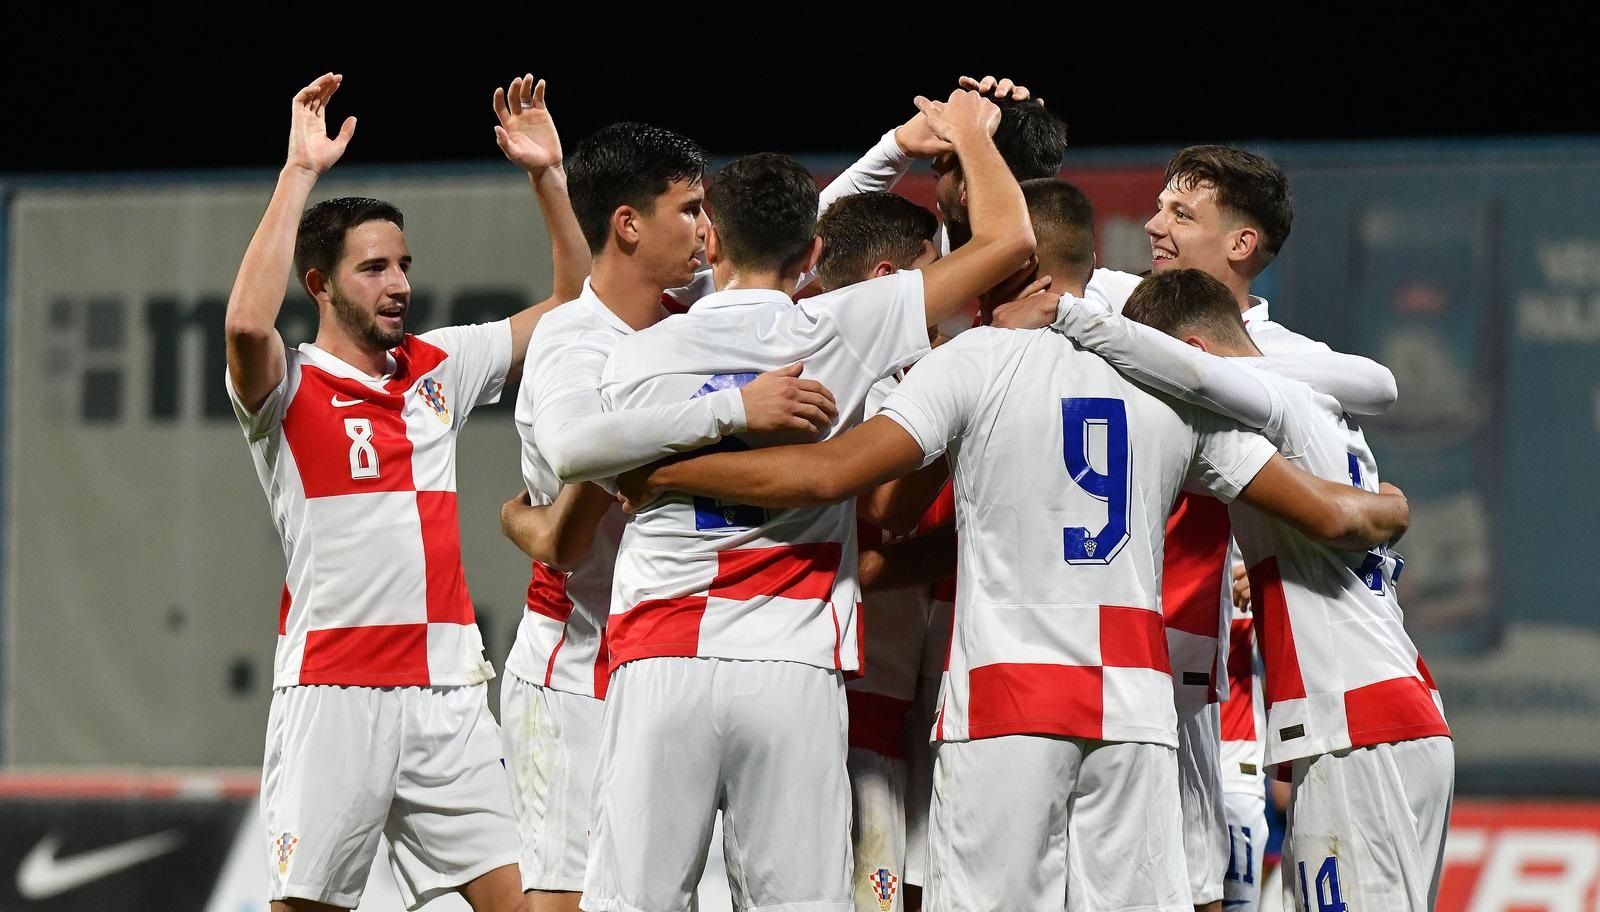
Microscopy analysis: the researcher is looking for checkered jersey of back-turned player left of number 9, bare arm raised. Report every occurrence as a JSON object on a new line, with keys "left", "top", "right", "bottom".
{"left": 603, "top": 272, "right": 928, "bottom": 670}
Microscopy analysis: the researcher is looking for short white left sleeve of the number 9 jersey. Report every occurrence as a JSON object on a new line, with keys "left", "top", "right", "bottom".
{"left": 878, "top": 333, "right": 990, "bottom": 466}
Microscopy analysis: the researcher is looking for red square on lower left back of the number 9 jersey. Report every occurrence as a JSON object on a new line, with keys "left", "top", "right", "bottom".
{"left": 966, "top": 659, "right": 1100, "bottom": 739}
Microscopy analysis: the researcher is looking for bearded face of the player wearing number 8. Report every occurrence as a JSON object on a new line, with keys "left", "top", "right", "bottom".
{"left": 328, "top": 221, "right": 411, "bottom": 350}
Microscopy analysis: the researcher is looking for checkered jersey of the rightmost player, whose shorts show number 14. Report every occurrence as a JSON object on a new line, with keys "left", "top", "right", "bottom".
{"left": 1230, "top": 358, "right": 1450, "bottom": 763}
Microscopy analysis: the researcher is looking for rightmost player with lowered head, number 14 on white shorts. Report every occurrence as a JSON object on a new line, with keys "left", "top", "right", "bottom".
{"left": 1077, "top": 270, "right": 1454, "bottom": 912}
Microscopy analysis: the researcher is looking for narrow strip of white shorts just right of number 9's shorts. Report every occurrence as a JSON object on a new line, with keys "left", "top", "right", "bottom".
{"left": 1178, "top": 702, "right": 1227, "bottom": 906}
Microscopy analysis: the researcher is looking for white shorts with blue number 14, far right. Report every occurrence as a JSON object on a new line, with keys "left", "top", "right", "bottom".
{"left": 1283, "top": 738, "right": 1456, "bottom": 912}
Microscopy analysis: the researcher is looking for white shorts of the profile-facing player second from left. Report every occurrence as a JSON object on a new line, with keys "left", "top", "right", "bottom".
{"left": 501, "top": 672, "right": 605, "bottom": 893}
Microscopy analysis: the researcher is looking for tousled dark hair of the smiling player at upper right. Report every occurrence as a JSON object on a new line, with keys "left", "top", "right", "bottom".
{"left": 1163, "top": 146, "right": 1294, "bottom": 270}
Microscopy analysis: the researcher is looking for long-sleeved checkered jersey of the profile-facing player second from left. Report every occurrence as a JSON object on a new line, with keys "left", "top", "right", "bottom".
{"left": 506, "top": 280, "right": 744, "bottom": 699}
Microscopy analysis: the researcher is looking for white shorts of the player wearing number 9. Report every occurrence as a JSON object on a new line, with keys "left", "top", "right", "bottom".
{"left": 923, "top": 734, "right": 1192, "bottom": 912}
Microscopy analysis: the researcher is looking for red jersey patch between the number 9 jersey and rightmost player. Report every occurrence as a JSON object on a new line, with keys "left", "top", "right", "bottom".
{"left": 1162, "top": 491, "right": 1232, "bottom": 640}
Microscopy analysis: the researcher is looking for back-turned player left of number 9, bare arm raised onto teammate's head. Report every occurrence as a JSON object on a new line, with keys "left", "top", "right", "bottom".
{"left": 584, "top": 91, "right": 1032, "bottom": 910}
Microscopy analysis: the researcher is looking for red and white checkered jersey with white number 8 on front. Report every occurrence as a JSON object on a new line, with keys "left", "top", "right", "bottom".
{"left": 227, "top": 320, "right": 510, "bottom": 686}
